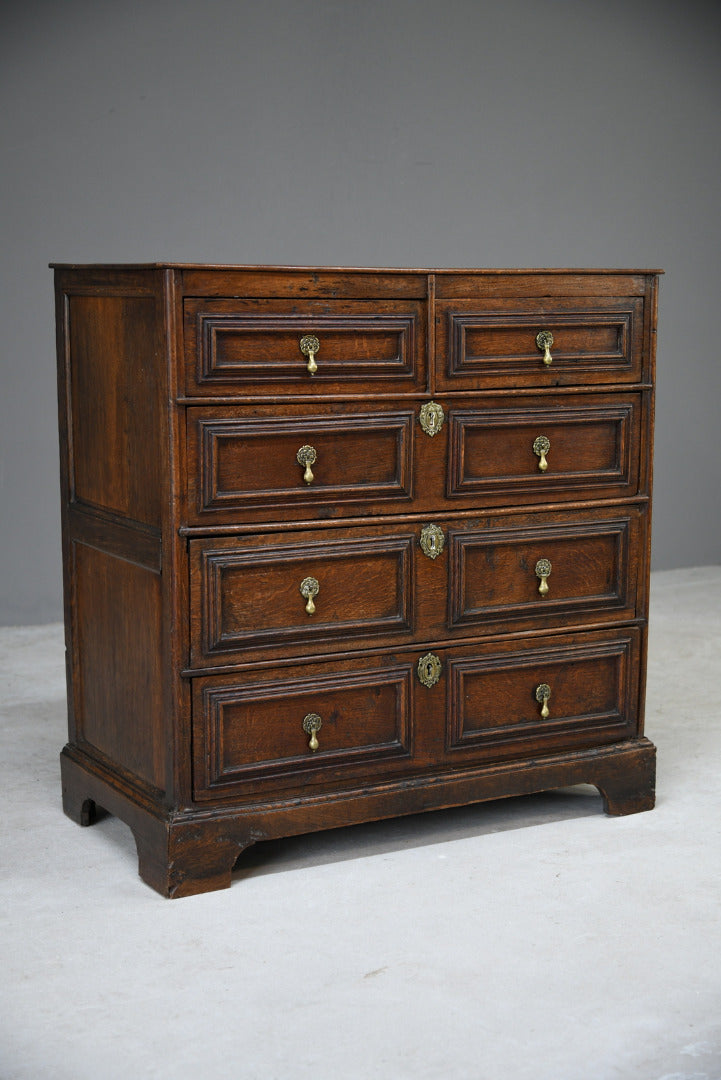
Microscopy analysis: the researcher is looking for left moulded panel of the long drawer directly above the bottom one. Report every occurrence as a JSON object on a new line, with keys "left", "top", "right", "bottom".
{"left": 190, "top": 527, "right": 417, "bottom": 664}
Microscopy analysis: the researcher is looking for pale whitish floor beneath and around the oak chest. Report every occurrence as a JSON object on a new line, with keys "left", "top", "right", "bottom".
{"left": 0, "top": 567, "right": 721, "bottom": 1080}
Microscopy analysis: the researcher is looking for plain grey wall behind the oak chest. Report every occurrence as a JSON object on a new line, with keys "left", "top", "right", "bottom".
{"left": 0, "top": 0, "right": 721, "bottom": 624}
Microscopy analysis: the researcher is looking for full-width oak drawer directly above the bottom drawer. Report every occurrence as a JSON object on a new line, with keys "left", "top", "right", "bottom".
{"left": 190, "top": 504, "right": 647, "bottom": 667}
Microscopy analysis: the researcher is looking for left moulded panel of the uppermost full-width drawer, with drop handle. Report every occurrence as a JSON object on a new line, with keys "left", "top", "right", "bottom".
{"left": 188, "top": 405, "right": 416, "bottom": 522}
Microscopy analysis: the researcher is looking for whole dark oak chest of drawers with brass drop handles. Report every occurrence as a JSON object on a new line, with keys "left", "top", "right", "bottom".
{"left": 55, "top": 265, "right": 657, "bottom": 896}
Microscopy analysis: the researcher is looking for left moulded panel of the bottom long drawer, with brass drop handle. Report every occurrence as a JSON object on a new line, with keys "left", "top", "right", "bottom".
{"left": 193, "top": 662, "right": 412, "bottom": 799}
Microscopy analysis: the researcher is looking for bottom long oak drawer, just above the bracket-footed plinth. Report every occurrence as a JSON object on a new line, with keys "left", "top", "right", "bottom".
{"left": 193, "top": 626, "right": 642, "bottom": 801}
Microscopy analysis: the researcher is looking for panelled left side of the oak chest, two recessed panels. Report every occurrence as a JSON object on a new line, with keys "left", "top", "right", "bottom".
{"left": 56, "top": 270, "right": 168, "bottom": 799}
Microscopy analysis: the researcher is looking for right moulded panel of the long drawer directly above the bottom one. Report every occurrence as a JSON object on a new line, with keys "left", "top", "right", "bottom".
{"left": 448, "top": 505, "right": 647, "bottom": 634}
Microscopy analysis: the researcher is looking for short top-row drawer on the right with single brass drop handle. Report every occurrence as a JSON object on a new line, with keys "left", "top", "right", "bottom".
{"left": 436, "top": 297, "right": 643, "bottom": 391}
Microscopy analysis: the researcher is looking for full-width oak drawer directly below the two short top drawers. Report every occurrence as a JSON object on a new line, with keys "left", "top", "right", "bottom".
{"left": 187, "top": 392, "right": 647, "bottom": 526}
